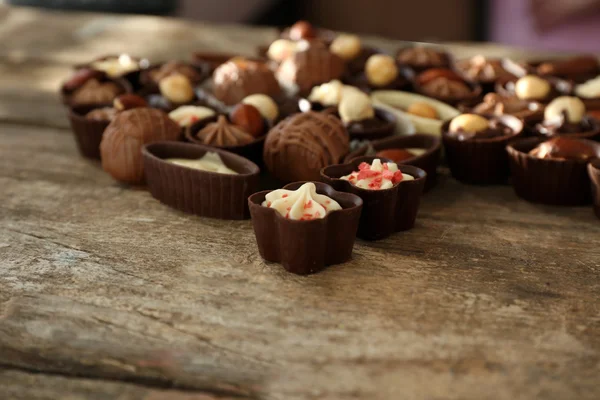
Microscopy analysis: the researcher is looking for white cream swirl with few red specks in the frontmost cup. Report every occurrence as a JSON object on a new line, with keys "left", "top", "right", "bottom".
{"left": 262, "top": 182, "right": 342, "bottom": 221}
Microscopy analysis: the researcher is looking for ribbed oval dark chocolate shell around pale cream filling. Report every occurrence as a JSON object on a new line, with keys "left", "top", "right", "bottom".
{"left": 142, "top": 142, "right": 260, "bottom": 219}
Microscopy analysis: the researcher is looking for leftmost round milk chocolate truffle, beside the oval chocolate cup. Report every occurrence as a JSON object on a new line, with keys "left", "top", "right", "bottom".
{"left": 100, "top": 107, "right": 181, "bottom": 183}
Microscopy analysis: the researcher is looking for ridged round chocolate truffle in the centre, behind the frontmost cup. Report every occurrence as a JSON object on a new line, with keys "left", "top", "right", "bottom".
{"left": 264, "top": 111, "right": 350, "bottom": 182}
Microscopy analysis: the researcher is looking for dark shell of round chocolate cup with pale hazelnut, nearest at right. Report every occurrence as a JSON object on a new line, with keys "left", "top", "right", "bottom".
{"left": 442, "top": 115, "right": 523, "bottom": 185}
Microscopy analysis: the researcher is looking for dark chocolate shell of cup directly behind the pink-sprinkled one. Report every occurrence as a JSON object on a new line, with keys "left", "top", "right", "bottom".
{"left": 345, "top": 133, "right": 442, "bottom": 191}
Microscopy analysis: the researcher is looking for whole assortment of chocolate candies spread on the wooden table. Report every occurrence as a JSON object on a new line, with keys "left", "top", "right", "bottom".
{"left": 60, "top": 21, "right": 600, "bottom": 274}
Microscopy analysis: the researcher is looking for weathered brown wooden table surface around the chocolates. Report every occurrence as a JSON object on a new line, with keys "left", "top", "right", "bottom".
{"left": 0, "top": 8, "right": 600, "bottom": 400}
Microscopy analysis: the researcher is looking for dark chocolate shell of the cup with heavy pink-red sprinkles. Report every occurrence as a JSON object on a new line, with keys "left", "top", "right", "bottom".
{"left": 321, "top": 156, "right": 427, "bottom": 240}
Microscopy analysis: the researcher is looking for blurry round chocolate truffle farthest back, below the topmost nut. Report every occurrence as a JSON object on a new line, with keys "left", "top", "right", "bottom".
{"left": 277, "top": 42, "right": 345, "bottom": 93}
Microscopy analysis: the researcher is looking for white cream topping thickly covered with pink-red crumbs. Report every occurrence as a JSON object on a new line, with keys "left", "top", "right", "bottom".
{"left": 340, "top": 158, "right": 415, "bottom": 190}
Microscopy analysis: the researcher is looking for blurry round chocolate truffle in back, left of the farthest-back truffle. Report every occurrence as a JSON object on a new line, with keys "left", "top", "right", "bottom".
{"left": 213, "top": 57, "right": 281, "bottom": 105}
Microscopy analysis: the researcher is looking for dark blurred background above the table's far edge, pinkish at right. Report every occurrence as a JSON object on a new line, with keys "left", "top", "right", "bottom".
{"left": 7, "top": 0, "right": 600, "bottom": 52}
